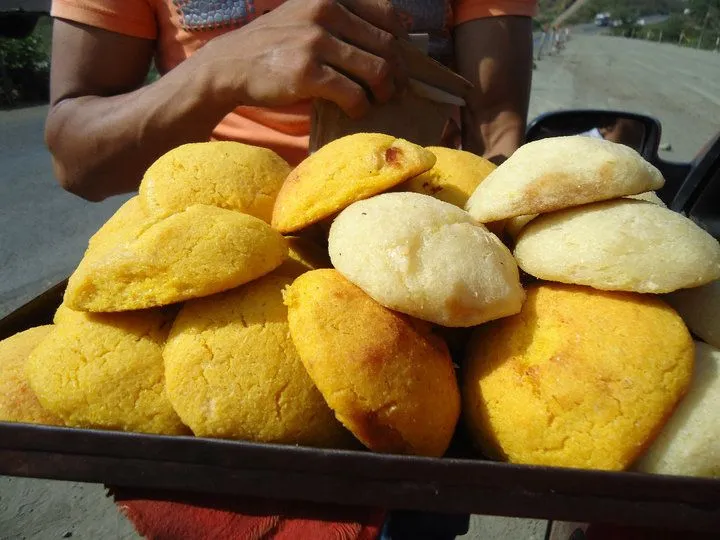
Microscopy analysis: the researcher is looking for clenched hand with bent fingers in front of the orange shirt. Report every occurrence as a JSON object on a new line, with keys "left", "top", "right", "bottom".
{"left": 196, "top": 0, "right": 406, "bottom": 118}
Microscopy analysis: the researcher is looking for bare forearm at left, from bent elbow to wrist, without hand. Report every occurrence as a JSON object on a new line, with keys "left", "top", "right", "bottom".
{"left": 46, "top": 53, "right": 233, "bottom": 200}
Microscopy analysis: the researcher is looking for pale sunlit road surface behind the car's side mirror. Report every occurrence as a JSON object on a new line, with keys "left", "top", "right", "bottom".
{"left": 530, "top": 35, "right": 720, "bottom": 161}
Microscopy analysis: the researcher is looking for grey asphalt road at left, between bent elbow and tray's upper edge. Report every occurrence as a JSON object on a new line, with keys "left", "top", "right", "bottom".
{"left": 0, "top": 107, "right": 131, "bottom": 316}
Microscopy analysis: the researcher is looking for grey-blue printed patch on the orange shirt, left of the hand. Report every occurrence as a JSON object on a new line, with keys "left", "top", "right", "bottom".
{"left": 173, "top": 0, "right": 256, "bottom": 32}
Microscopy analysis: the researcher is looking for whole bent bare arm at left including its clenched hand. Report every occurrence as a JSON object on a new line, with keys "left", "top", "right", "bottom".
{"left": 45, "top": 0, "right": 404, "bottom": 200}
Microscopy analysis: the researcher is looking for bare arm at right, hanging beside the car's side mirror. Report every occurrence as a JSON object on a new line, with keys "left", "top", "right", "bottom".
{"left": 455, "top": 17, "right": 532, "bottom": 161}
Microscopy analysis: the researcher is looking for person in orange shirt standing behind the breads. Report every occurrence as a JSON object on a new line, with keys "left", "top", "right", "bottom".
{"left": 46, "top": 0, "right": 536, "bottom": 200}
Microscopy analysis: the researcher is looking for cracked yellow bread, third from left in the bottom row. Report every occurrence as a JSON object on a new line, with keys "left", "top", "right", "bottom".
{"left": 163, "top": 269, "right": 352, "bottom": 447}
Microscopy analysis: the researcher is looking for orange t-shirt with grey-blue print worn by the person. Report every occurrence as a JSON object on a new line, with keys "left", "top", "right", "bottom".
{"left": 52, "top": 0, "right": 537, "bottom": 164}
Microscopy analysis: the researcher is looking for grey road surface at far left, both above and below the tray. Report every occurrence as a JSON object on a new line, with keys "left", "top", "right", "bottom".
{"left": 0, "top": 107, "right": 138, "bottom": 540}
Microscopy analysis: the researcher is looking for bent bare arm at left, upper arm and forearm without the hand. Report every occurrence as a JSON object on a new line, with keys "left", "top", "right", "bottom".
{"left": 45, "top": 20, "right": 230, "bottom": 201}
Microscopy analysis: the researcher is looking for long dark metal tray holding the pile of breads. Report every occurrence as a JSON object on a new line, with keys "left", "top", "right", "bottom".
{"left": 0, "top": 282, "right": 720, "bottom": 532}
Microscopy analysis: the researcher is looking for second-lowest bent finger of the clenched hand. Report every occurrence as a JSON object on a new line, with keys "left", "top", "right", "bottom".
{"left": 320, "top": 34, "right": 395, "bottom": 103}
